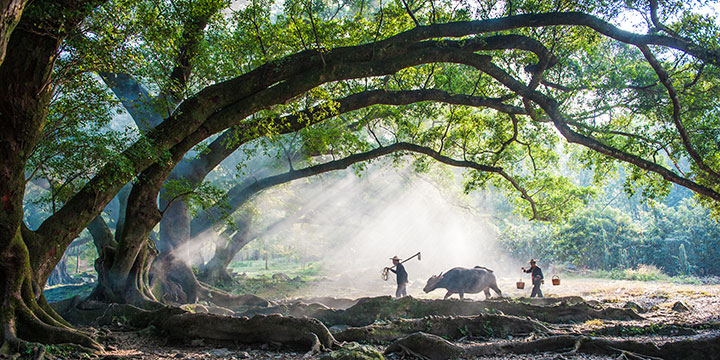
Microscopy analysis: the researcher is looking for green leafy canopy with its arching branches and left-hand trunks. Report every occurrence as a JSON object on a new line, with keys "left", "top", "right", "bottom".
{"left": 0, "top": 0, "right": 720, "bottom": 347}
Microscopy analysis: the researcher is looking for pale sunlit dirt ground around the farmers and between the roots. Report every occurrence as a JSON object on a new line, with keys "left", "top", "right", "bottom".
{"left": 36, "top": 279, "right": 720, "bottom": 360}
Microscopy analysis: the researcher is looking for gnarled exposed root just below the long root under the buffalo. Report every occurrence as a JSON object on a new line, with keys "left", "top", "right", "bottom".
{"left": 334, "top": 315, "right": 550, "bottom": 342}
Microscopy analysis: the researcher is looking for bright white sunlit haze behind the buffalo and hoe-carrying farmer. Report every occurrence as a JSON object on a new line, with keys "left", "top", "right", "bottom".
{"left": 242, "top": 160, "right": 519, "bottom": 297}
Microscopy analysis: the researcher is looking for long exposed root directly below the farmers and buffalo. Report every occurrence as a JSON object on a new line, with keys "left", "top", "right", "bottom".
{"left": 240, "top": 296, "right": 643, "bottom": 326}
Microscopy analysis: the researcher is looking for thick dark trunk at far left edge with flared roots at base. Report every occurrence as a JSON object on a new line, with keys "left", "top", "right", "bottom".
{"left": 0, "top": 1, "right": 106, "bottom": 351}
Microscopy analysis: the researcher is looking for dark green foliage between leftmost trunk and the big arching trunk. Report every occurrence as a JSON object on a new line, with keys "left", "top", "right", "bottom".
{"left": 26, "top": 74, "right": 136, "bottom": 217}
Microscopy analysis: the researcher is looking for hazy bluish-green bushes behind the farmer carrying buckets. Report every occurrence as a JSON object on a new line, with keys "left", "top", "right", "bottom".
{"left": 500, "top": 188, "right": 720, "bottom": 276}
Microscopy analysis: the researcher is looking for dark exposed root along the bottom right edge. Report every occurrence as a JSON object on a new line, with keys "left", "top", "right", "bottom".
{"left": 386, "top": 333, "right": 720, "bottom": 360}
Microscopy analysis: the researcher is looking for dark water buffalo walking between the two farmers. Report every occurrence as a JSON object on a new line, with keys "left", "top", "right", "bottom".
{"left": 423, "top": 266, "right": 502, "bottom": 299}
